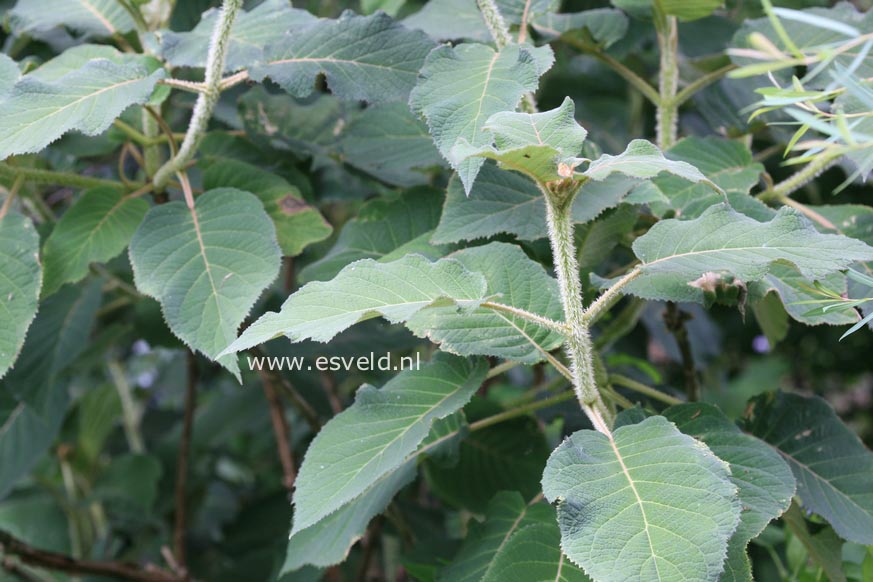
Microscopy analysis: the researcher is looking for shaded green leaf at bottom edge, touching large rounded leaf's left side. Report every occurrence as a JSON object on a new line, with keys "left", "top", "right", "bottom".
{"left": 482, "top": 521, "right": 591, "bottom": 582}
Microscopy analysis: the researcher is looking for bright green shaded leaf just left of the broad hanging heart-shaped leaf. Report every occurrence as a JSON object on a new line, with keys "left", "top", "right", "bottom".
{"left": 42, "top": 188, "right": 149, "bottom": 297}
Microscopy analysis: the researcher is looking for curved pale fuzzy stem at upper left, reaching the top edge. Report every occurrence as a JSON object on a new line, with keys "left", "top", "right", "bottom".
{"left": 154, "top": 0, "right": 242, "bottom": 189}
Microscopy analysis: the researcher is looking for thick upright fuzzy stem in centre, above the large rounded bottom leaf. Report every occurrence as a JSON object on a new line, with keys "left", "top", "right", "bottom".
{"left": 543, "top": 190, "right": 612, "bottom": 434}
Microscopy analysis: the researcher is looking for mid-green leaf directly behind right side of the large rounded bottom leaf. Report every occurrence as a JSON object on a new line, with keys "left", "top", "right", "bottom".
{"left": 664, "top": 403, "right": 796, "bottom": 582}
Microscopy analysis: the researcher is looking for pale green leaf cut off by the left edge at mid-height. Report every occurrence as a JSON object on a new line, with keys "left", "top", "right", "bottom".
{"left": 0, "top": 212, "right": 42, "bottom": 378}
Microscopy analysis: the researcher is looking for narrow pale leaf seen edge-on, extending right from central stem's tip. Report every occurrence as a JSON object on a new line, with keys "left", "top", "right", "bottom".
{"left": 581, "top": 139, "right": 719, "bottom": 190}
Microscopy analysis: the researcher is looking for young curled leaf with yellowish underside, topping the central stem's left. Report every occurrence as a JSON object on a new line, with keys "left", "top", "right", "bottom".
{"left": 450, "top": 97, "right": 588, "bottom": 184}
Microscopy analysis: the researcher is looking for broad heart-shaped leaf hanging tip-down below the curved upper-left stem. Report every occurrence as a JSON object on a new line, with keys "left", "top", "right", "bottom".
{"left": 130, "top": 188, "right": 281, "bottom": 377}
